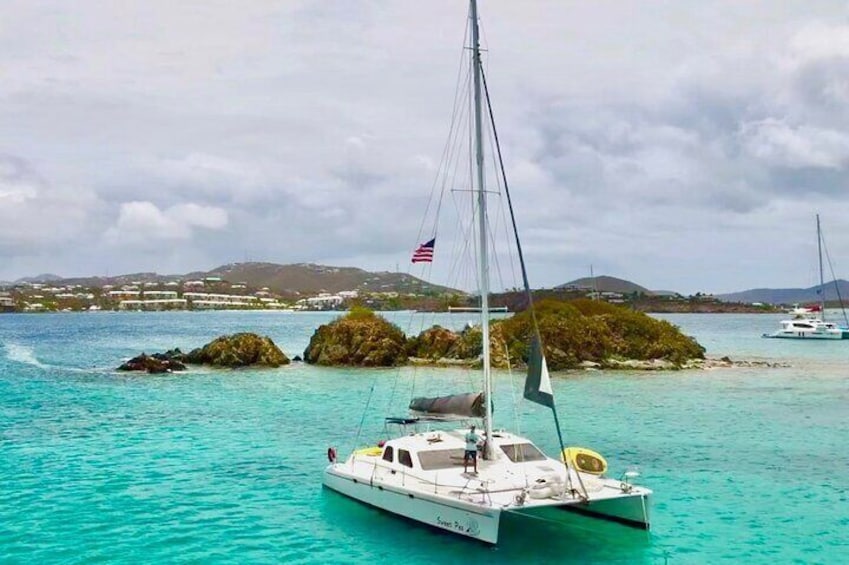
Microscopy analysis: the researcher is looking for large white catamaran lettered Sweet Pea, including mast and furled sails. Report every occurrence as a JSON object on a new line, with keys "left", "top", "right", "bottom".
{"left": 323, "top": 0, "right": 652, "bottom": 544}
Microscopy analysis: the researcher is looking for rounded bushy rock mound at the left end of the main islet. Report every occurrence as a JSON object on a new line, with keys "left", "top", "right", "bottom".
{"left": 304, "top": 308, "right": 407, "bottom": 367}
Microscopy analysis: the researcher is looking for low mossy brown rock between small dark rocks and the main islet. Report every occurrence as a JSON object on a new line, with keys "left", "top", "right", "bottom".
{"left": 185, "top": 333, "right": 289, "bottom": 367}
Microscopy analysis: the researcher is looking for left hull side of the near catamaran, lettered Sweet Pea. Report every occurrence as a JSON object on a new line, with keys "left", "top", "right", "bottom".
{"left": 323, "top": 464, "right": 501, "bottom": 544}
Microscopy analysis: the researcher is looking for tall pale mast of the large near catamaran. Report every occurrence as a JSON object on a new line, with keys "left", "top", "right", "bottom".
{"left": 469, "top": 0, "right": 493, "bottom": 459}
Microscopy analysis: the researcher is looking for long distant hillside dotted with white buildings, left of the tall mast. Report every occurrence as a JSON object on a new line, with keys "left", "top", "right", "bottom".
{"left": 13, "top": 263, "right": 464, "bottom": 296}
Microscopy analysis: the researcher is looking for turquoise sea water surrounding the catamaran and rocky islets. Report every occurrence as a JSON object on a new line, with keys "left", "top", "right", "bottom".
{"left": 0, "top": 312, "right": 849, "bottom": 563}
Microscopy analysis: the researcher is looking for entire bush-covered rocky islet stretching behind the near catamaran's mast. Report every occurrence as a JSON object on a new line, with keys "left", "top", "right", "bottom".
{"left": 304, "top": 299, "right": 705, "bottom": 371}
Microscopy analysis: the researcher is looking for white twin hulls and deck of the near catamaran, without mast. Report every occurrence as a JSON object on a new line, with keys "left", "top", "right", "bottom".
{"left": 323, "top": 438, "right": 651, "bottom": 544}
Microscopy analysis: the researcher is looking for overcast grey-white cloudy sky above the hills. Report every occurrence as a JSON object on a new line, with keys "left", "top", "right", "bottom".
{"left": 0, "top": 0, "right": 849, "bottom": 294}
